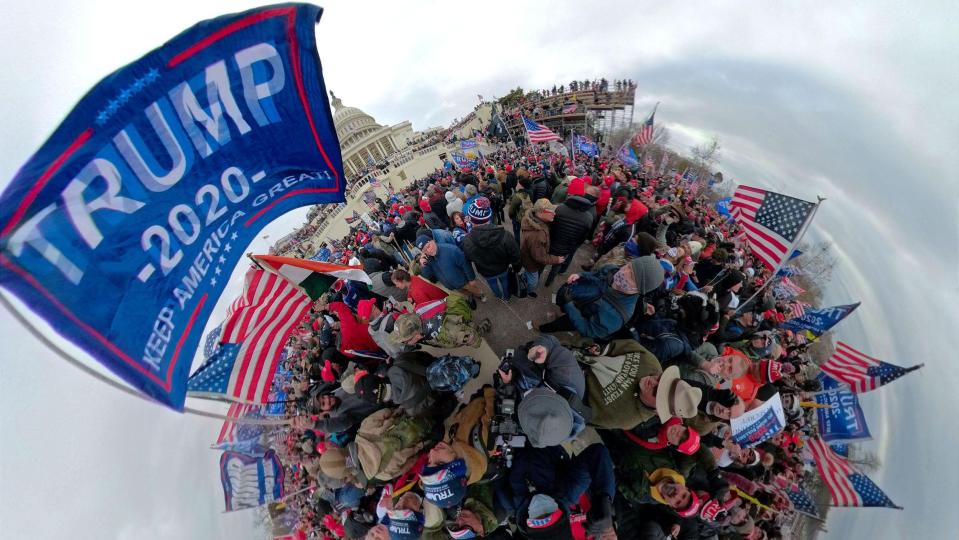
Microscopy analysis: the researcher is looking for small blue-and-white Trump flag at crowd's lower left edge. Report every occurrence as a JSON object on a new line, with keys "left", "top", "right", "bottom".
{"left": 220, "top": 450, "right": 285, "bottom": 512}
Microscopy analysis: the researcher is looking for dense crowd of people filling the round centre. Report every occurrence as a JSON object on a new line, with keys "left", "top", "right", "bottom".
{"left": 262, "top": 136, "right": 817, "bottom": 540}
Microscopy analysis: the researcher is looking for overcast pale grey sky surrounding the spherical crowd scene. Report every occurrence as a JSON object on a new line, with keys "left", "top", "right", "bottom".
{"left": 0, "top": 0, "right": 959, "bottom": 539}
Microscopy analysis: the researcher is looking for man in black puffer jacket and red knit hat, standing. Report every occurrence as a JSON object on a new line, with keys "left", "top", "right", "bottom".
{"left": 546, "top": 178, "right": 596, "bottom": 287}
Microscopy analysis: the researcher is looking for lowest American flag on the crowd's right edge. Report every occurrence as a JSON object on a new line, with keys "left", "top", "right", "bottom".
{"left": 806, "top": 437, "right": 899, "bottom": 508}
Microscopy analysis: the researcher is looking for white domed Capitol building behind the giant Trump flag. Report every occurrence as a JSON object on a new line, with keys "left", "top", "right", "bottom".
{"left": 330, "top": 92, "right": 414, "bottom": 178}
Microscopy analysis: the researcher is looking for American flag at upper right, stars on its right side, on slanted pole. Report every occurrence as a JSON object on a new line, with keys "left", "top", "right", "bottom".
{"left": 729, "top": 186, "right": 816, "bottom": 268}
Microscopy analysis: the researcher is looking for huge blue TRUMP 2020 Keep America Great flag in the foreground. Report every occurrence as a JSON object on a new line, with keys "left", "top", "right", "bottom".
{"left": 0, "top": 4, "right": 345, "bottom": 410}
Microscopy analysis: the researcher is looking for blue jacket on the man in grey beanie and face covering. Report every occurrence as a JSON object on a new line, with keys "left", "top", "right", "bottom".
{"left": 557, "top": 266, "right": 639, "bottom": 338}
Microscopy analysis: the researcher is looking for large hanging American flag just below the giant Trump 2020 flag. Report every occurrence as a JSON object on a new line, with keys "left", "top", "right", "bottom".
{"left": 187, "top": 268, "right": 310, "bottom": 403}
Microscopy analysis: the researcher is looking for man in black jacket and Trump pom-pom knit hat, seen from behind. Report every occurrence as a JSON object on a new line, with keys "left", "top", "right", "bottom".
{"left": 463, "top": 197, "right": 521, "bottom": 300}
